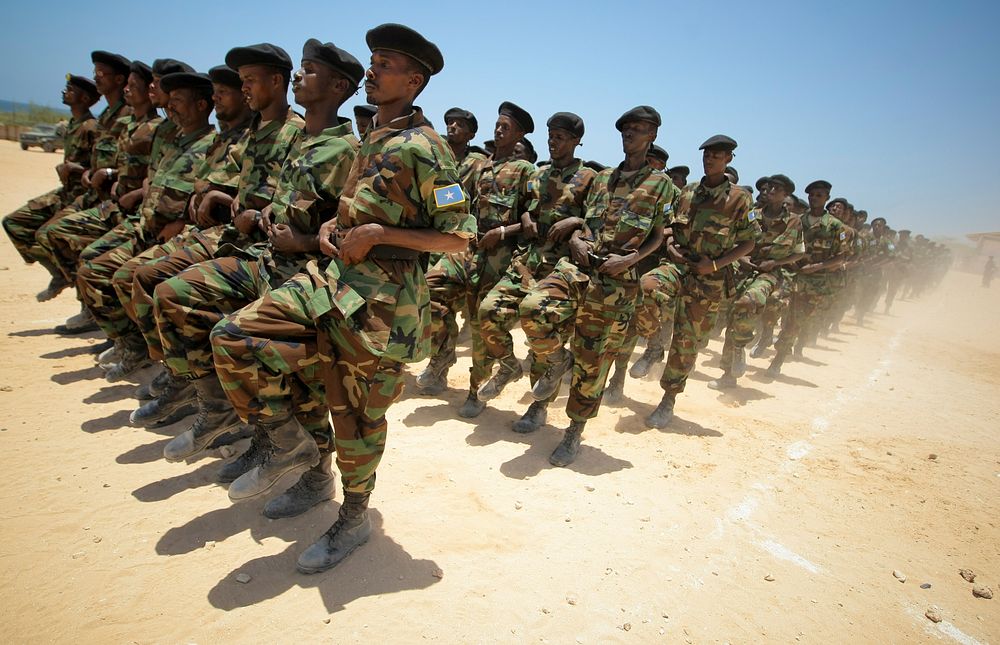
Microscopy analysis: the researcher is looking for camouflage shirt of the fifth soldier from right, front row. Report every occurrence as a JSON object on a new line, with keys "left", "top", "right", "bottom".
{"left": 139, "top": 126, "right": 215, "bottom": 239}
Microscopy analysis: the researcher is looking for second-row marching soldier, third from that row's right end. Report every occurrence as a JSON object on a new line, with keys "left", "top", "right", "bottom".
{"left": 418, "top": 101, "right": 535, "bottom": 412}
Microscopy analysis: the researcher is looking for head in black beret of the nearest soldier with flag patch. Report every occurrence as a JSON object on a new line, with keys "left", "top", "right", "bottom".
{"left": 365, "top": 23, "right": 444, "bottom": 105}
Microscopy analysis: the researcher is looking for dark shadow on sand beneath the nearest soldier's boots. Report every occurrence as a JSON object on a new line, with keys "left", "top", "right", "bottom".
{"left": 208, "top": 505, "right": 441, "bottom": 614}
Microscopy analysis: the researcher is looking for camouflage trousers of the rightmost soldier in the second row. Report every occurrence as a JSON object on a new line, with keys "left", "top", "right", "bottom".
{"left": 520, "top": 258, "right": 639, "bottom": 422}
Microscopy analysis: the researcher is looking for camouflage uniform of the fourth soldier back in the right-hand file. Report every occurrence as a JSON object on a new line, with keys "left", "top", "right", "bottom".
{"left": 775, "top": 213, "right": 848, "bottom": 355}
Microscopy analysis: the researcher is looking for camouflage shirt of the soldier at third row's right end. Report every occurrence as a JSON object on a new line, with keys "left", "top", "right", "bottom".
{"left": 670, "top": 179, "right": 761, "bottom": 260}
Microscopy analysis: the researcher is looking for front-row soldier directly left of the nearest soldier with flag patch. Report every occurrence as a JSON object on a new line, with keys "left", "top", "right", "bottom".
{"left": 154, "top": 38, "right": 364, "bottom": 498}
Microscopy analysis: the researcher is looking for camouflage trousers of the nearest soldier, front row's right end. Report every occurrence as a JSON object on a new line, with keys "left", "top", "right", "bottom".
{"left": 212, "top": 263, "right": 403, "bottom": 493}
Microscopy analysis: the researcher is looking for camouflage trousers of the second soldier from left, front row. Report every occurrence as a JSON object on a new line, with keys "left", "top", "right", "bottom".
{"left": 35, "top": 201, "right": 124, "bottom": 283}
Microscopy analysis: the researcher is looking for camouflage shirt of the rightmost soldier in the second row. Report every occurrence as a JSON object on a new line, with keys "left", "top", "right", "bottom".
{"left": 584, "top": 162, "right": 678, "bottom": 260}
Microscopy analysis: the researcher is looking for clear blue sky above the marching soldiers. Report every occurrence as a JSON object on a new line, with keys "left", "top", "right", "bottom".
{"left": 0, "top": 0, "right": 1000, "bottom": 235}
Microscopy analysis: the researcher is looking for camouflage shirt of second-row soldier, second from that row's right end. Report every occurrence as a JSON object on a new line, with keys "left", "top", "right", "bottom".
{"left": 514, "top": 159, "right": 597, "bottom": 277}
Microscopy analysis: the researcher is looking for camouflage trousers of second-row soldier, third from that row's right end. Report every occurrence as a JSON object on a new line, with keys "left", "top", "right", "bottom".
{"left": 426, "top": 243, "right": 513, "bottom": 392}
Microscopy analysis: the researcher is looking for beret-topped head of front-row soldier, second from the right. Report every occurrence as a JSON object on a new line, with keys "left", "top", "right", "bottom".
{"left": 292, "top": 38, "right": 365, "bottom": 110}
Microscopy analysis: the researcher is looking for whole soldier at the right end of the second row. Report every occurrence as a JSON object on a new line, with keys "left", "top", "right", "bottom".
{"left": 520, "top": 105, "right": 677, "bottom": 466}
